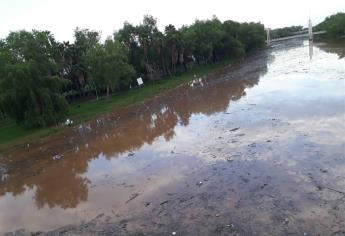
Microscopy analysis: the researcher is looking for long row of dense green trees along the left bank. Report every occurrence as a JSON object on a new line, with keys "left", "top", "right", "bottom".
{"left": 0, "top": 16, "right": 265, "bottom": 127}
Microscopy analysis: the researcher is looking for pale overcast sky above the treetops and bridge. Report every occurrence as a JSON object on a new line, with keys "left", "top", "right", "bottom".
{"left": 0, "top": 0, "right": 345, "bottom": 41}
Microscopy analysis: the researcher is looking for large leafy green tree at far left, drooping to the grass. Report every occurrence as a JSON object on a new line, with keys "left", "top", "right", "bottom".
{"left": 0, "top": 31, "right": 68, "bottom": 127}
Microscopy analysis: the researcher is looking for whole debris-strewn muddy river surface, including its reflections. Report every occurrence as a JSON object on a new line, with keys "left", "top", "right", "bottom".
{"left": 0, "top": 41, "right": 345, "bottom": 235}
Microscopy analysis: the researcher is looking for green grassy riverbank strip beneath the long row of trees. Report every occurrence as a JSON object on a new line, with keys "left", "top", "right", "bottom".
{"left": 0, "top": 62, "right": 229, "bottom": 151}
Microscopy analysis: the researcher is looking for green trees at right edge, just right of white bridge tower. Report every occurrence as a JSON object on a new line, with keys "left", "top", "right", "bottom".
{"left": 314, "top": 12, "right": 345, "bottom": 39}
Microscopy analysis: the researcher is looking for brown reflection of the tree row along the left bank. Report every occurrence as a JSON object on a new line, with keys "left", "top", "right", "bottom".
{"left": 0, "top": 51, "right": 267, "bottom": 208}
